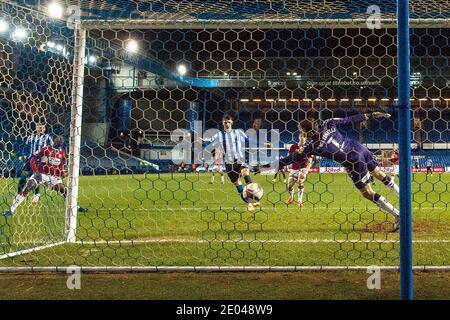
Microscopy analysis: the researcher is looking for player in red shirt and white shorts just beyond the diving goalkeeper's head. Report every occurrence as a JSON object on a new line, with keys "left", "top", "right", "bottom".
{"left": 287, "top": 134, "right": 312, "bottom": 207}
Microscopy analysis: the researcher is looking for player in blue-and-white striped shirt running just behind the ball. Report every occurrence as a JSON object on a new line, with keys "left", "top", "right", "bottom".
{"left": 203, "top": 113, "right": 259, "bottom": 211}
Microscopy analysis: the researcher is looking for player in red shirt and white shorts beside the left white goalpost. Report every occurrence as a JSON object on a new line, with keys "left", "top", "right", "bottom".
{"left": 3, "top": 136, "right": 87, "bottom": 217}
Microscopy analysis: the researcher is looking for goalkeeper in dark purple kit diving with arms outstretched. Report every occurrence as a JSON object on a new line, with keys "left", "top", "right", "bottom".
{"left": 266, "top": 112, "right": 399, "bottom": 231}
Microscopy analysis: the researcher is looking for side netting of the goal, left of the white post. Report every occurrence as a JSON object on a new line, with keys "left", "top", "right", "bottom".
{"left": 0, "top": 4, "right": 72, "bottom": 254}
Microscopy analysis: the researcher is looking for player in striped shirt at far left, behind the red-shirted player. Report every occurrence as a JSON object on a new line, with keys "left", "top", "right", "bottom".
{"left": 17, "top": 123, "right": 53, "bottom": 203}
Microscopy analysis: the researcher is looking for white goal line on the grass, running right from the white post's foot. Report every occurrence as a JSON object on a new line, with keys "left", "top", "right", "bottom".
{"left": 75, "top": 238, "right": 450, "bottom": 245}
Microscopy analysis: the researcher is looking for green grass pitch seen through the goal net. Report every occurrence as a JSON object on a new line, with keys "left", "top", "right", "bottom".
{"left": 0, "top": 173, "right": 450, "bottom": 266}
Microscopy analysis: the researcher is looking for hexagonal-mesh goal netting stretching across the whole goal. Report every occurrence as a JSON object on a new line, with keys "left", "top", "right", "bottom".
{"left": 0, "top": 1, "right": 450, "bottom": 266}
